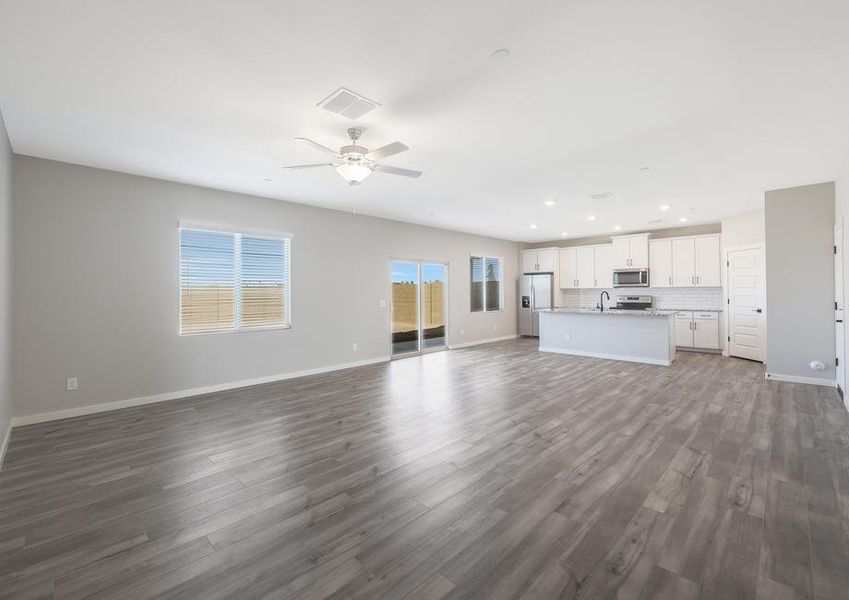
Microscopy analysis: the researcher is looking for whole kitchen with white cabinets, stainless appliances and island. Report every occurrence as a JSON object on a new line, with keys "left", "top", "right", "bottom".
{"left": 519, "top": 230, "right": 725, "bottom": 366}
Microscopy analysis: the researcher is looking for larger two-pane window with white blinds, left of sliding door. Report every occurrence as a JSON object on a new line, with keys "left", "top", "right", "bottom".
{"left": 180, "top": 227, "right": 291, "bottom": 334}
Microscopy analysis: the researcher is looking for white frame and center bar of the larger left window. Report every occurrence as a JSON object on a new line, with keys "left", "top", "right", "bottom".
{"left": 177, "top": 221, "right": 294, "bottom": 337}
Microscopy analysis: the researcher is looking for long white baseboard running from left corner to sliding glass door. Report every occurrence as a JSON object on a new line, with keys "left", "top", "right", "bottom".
{"left": 10, "top": 356, "right": 389, "bottom": 429}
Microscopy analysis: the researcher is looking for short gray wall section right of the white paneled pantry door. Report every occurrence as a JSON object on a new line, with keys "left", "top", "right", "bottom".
{"left": 764, "top": 183, "right": 835, "bottom": 382}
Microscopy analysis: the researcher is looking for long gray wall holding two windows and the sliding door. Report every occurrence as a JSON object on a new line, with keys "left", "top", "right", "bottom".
{"left": 13, "top": 156, "right": 518, "bottom": 416}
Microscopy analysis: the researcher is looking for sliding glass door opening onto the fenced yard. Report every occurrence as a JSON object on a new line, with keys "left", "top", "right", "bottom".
{"left": 392, "top": 260, "right": 448, "bottom": 356}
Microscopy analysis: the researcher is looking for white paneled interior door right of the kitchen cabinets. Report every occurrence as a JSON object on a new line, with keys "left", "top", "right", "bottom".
{"left": 728, "top": 248, "right": 766, "bottom": 362}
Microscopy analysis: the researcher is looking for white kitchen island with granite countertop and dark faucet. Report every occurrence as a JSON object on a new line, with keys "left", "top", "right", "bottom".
{"left": 539, "top": 308, "right": 675, "bottom": 367}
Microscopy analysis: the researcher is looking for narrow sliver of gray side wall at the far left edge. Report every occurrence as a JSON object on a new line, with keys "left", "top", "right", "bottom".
{"left": 0, "top": 112, "right": 12, "bottom": 442}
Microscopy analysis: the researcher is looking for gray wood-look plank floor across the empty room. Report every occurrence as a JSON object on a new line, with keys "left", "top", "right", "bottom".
{"left": 0, "top": 340, "right": 849, "bottom": 600}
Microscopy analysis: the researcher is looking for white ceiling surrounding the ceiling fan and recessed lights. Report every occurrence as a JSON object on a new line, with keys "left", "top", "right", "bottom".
{"left": 0, "top": 0, "right": 849, "bottom": 241}
